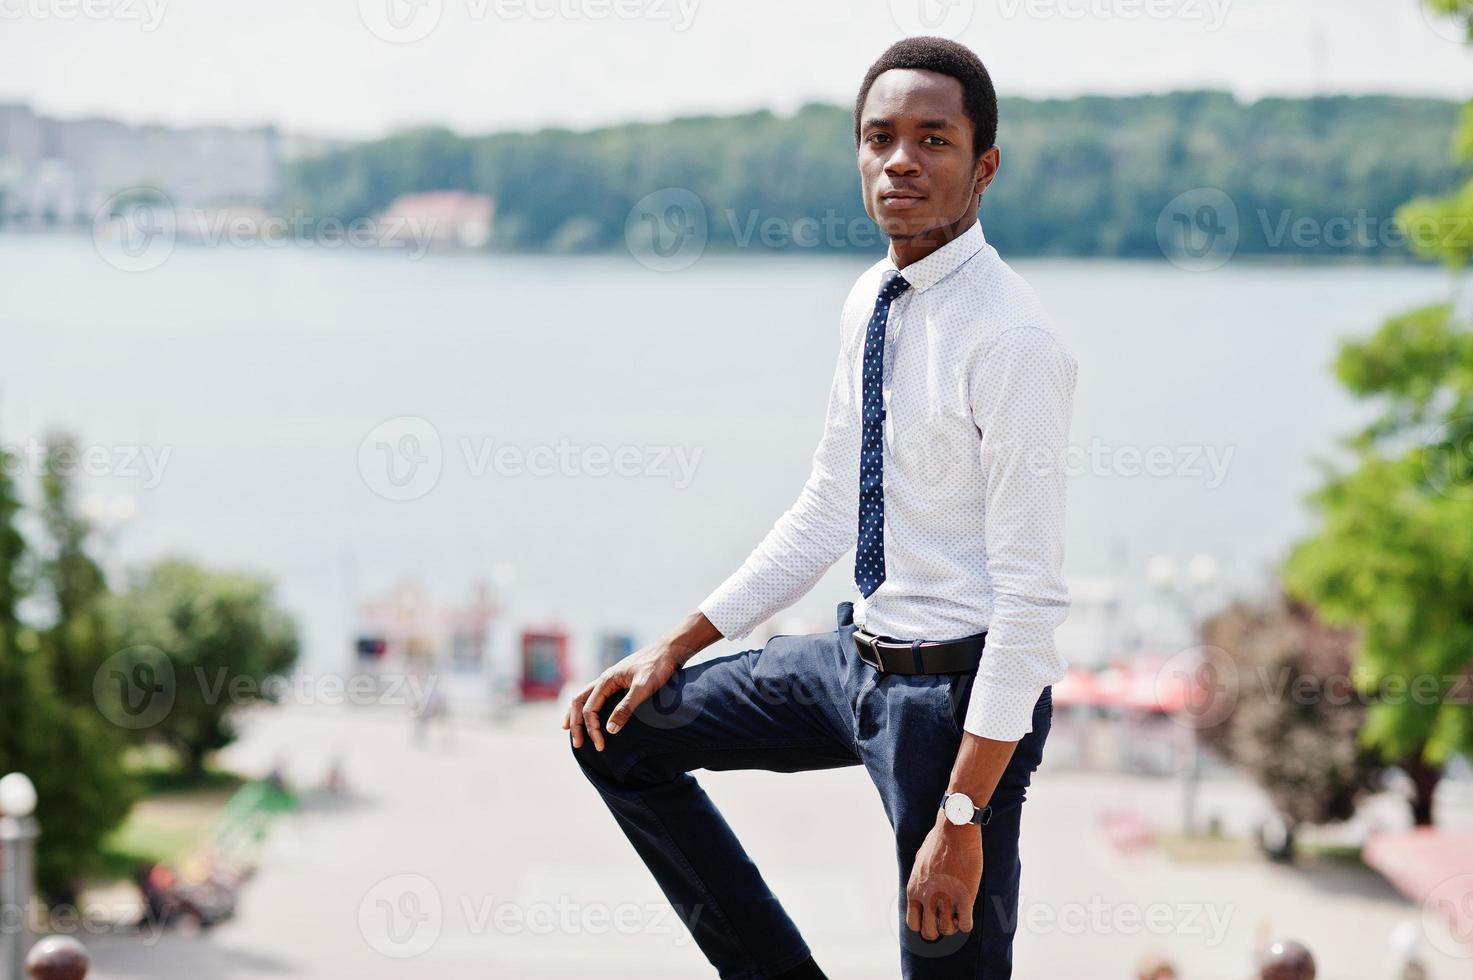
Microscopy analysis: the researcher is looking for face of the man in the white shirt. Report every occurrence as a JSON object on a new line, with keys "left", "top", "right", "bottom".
{"left": 859, "top": 68, "right": 999, "bottom": 239}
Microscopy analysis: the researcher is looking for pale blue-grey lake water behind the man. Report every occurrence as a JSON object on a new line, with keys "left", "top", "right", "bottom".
{"left": 0, "top": 236, "right": 1448, "bottom": 669}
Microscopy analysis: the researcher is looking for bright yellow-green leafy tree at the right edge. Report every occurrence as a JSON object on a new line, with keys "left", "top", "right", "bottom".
{"left": 1284, "top": 0, "right": 1473, "bottom": 825}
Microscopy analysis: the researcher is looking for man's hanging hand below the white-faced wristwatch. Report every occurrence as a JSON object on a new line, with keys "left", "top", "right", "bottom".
{"left": 906, "top": 809, "right": 982, "bottom": 942}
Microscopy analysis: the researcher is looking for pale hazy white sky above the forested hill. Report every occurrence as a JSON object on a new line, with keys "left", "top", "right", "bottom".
{"left": 0, "top": 0, "right": 1473, "bottom": 137}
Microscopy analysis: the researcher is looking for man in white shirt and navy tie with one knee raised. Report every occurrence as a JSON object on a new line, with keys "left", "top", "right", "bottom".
{"left": 563, "top": 37, "right": 1075, "bottom": 980}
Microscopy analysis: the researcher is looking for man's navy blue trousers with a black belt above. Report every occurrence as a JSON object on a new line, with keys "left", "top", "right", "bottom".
{"left": 573, "top": 603, "right": 1053, "bottom": 980}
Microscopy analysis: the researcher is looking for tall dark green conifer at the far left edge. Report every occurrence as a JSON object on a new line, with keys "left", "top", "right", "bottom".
{"left": 0, "top": 439, "right": 136, "bottom": 900}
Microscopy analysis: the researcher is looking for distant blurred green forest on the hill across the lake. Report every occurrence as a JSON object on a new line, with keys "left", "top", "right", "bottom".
{"left": 287, "top": 91, "right": 1464, "bottom": 258}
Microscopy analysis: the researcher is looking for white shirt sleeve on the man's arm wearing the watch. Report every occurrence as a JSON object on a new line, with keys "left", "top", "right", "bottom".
{"left": 963, "top": 326, "right": 1077, "bottom": 741}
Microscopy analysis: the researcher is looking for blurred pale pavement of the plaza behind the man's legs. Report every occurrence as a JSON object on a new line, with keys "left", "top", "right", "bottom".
{"left": 87, "top": 706, "right": 1473, "bottom": 980}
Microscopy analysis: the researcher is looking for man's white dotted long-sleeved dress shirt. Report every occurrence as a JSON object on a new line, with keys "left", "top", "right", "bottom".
{"left": 700, "top": 223, "right": 1077, "bottom": 741}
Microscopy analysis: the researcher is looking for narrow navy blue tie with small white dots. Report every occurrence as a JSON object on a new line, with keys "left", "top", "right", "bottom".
{"left": 854, "top": 270, "right": 910, "bottom": 598}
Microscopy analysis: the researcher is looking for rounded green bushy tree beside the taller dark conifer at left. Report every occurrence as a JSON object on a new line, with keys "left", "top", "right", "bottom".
{"left": 105, "top": 559, "right": 298, "bottom": 778}
